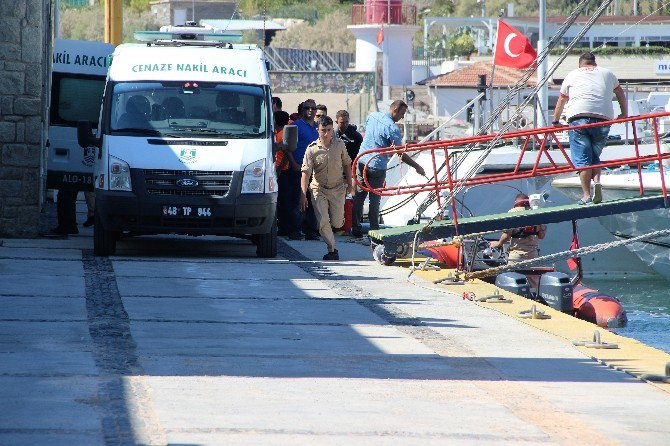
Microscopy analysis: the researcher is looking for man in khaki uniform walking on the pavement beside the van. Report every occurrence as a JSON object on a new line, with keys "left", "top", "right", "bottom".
{"left": 300, "top": 116, "right": 353, "bottom": 260}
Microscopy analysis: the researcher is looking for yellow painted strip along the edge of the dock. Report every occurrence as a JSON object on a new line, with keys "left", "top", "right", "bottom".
{"left": 404, "top": 260, "right": 670, "bottom": 393}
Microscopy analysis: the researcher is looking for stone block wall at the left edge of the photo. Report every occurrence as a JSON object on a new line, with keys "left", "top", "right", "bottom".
{"left": 0, "top": 0, "right": 50, "bottom": 237}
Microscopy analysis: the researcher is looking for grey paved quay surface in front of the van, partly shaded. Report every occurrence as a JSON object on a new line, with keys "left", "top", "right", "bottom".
{"left": 0, "top": 221, "right": 670, "bottom": 446}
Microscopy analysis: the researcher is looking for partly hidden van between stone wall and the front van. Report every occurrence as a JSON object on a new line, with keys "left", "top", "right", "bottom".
{"left": 46, "top": 39, "right": 114, "bottom": 191}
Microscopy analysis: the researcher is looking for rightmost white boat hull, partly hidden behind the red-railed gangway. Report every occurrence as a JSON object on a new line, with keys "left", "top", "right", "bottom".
{"left": 552, "top": 164, "right": 670, "bottom": 279}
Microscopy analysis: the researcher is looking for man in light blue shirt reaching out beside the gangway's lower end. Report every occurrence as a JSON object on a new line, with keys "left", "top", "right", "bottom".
{"left": 351, "top": 100, "right": 426, "bottom": 237}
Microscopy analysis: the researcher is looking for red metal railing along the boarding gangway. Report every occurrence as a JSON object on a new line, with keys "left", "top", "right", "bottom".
{"left": 352, "top": 112, "right": 670, "bottom": 230}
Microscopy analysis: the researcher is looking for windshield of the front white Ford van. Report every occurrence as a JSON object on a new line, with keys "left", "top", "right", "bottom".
{"left": 109, "top": 81, "right": 268, "bottom": 138}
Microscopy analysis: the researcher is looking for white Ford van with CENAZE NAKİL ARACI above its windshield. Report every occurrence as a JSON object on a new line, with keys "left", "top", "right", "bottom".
{"left": 79, "top": 27, "right": 277, "bottom": 257}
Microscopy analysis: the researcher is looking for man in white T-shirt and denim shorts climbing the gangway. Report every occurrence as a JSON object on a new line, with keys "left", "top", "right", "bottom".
{"left": 553, "top": 52, "right": 628, "bottom": 204}
